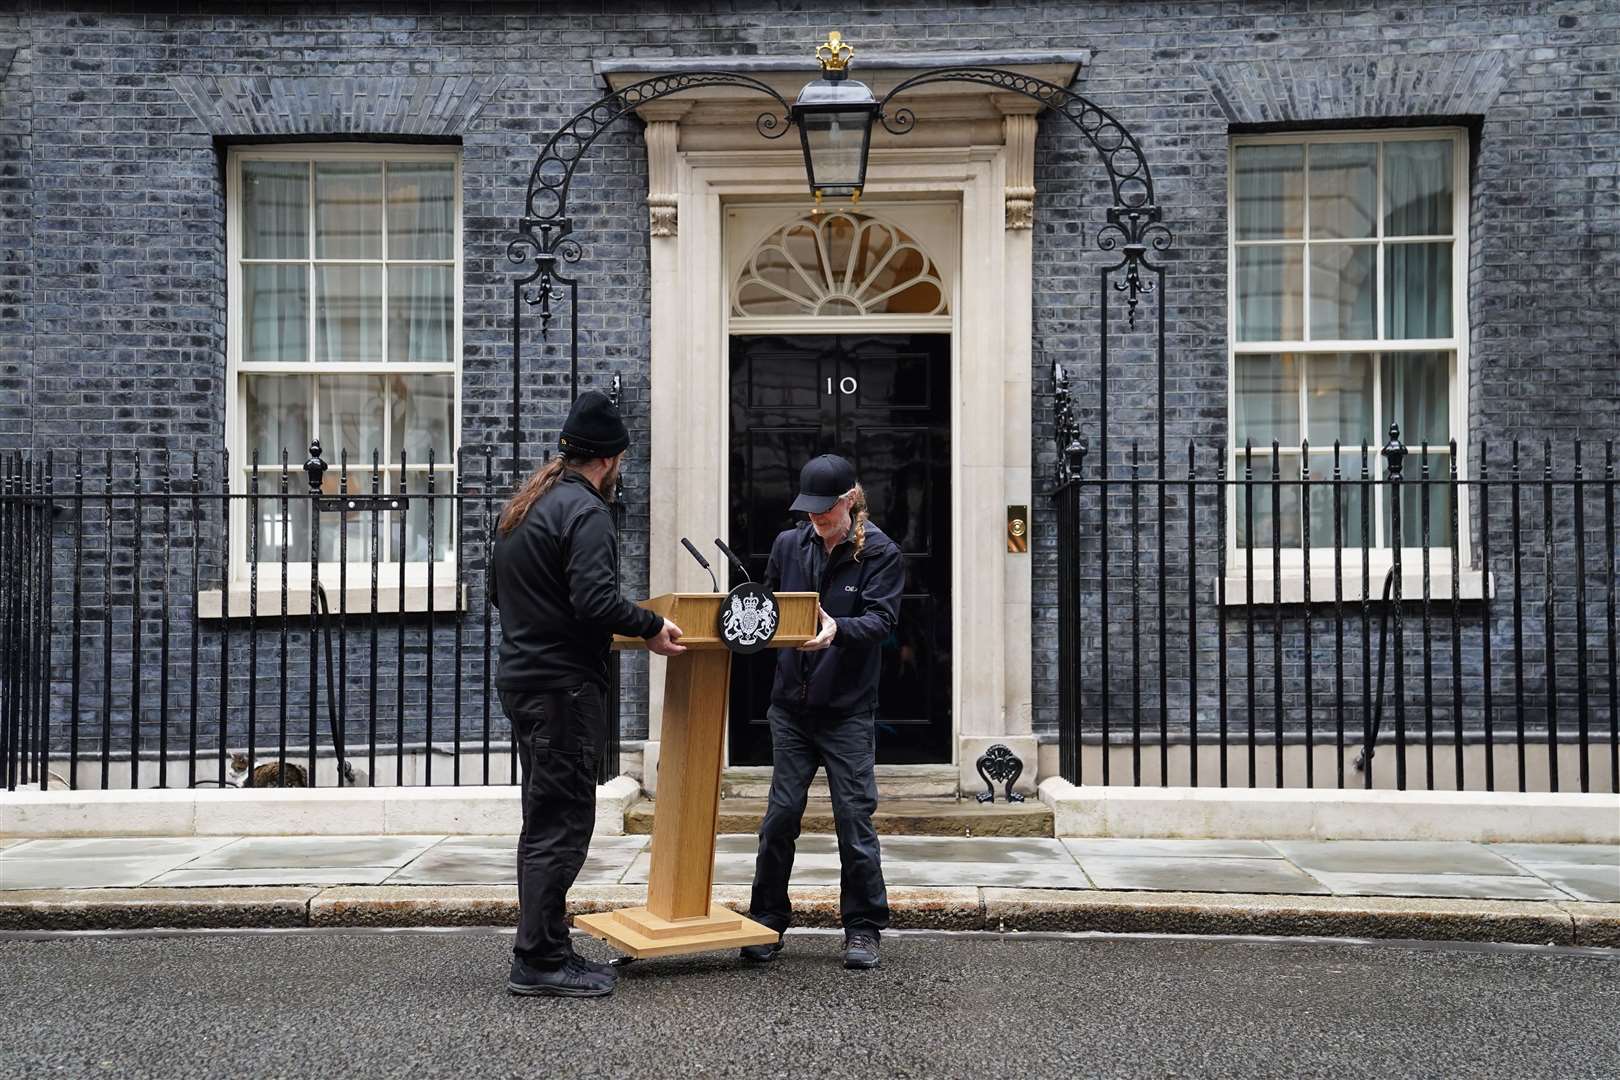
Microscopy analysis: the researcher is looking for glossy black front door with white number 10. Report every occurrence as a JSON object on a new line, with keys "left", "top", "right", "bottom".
{"left": 727, "top": 334, "right": 951, "bottom": 764}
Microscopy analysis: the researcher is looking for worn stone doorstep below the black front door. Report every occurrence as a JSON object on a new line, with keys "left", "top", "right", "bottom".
{"left": 624, "top": 798, "right": 1053, "bottom": 837}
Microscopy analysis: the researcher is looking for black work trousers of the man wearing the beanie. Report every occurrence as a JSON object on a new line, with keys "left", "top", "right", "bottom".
{"left": 501, "top": 683, "right": 608, "bottom": 970}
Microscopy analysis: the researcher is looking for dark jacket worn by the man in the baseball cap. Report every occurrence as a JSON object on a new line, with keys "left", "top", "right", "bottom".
{"left": 765, "top": 521, "right": 906, "bottom": 714}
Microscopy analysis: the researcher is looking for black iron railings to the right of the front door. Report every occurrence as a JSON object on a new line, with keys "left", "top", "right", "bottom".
{"left": 1053, "top": 429, "right": 1620, "bottom": 792}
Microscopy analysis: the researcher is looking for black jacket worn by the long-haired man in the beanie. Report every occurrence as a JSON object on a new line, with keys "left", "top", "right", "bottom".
{"left": 489, "top": 471, "right": 664, "bottom": 691}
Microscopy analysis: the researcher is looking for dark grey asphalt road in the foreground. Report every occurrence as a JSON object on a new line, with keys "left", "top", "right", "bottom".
{"left": 0, "top": 931, "right": 1620, "bottom": 1080}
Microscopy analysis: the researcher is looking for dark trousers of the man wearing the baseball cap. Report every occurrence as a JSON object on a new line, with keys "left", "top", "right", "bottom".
{"left": 748, "top": 704, "right": 889, "bottom": 931}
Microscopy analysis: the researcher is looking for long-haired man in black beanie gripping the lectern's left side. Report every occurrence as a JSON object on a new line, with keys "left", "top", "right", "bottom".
{"left": 489, "top": 390, "right": 685, "bottom": 997}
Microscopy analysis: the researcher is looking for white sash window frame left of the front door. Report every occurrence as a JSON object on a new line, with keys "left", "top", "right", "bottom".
{"left": 221, "top": 142, "right": 465, "bottom": 599}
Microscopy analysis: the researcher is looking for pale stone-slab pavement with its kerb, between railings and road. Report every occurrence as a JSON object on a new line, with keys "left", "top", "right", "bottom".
{"left": 0, "top": 834, "right": 1620, "bottom": 947}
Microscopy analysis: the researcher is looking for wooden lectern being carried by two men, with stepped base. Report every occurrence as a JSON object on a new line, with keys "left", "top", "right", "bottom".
{"left": 573, "top": 593, "right": 820, "bottom": 957}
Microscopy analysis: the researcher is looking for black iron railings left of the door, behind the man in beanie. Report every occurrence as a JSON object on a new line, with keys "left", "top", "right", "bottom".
{"left": 0, "top": 444, "right": 620, "bottom": 790}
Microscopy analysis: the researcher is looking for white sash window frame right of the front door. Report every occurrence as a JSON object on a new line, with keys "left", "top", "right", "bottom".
{"left": 1225, "top": 128, "right": 1489, "bottom": 604}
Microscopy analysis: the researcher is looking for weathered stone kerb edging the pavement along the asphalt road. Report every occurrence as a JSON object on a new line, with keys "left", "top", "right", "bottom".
{"left": 0, "top": 886, "right": 1620, "bottom": 949}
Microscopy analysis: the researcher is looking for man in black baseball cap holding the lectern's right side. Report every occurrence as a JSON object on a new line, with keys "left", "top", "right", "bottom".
{"left": 742, "top": 453, "right": 906, "bottom": 968}
